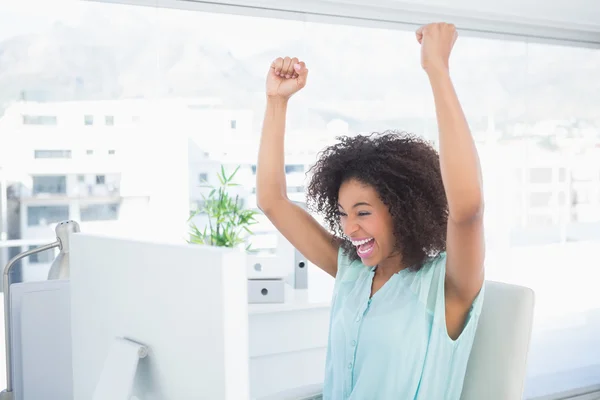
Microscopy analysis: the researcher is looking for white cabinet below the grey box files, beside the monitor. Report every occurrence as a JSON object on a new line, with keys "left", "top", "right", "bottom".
{"left": 248, "top": 287, "right": 330, "bottom": 399}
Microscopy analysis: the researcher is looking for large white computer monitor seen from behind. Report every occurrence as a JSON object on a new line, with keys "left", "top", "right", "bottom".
{"left": 71, "top": 233, "right": 249, "bottom": 400}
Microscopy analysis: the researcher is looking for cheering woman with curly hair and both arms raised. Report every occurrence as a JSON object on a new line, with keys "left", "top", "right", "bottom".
{"left": 257, "top": 23, "right": 485, "bottom": 400}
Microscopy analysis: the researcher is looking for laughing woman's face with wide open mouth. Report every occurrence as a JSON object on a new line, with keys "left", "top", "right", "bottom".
{"left": 338, "top": 179, "right": 397, "bottom": 267}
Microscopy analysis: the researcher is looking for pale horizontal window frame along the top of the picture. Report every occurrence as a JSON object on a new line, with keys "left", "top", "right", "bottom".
{"left": 91, "top": 0, "right": 600, "bottom": 48}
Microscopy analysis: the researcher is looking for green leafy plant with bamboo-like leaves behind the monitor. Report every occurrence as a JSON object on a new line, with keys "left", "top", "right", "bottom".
{"left": 188, "top": 165, "right": 258, "bottom": 251}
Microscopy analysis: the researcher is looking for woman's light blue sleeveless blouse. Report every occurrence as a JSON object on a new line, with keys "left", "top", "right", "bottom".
{"left": 323, "top": 249, "right": 483, "bottom": 400}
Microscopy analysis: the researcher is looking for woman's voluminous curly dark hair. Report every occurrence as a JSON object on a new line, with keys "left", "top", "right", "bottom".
{"left": 307, "top": 130, "right": 448, "bottom": 270}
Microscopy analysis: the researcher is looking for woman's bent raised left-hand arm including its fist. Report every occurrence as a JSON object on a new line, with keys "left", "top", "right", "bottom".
{"left": 256, "top": 57, "right": 339, "bottom": 277}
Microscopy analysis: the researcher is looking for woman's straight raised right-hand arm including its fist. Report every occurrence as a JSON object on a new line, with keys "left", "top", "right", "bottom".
{"left": 417, "top": 23, "right": 485, "bottom": 330}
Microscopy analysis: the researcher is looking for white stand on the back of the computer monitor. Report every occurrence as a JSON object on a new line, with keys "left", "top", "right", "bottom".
{"left": 93, "top": 337, "right": 148, "bottom": 400}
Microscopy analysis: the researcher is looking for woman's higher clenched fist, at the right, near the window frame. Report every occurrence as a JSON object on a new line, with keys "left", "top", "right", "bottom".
{"left": 416, "top": 23, "right": 458, "bottom": 74}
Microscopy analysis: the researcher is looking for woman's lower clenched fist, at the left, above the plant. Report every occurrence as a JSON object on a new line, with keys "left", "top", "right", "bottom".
{"left": 267, "top": 57, "right": 308, "bottom": 99}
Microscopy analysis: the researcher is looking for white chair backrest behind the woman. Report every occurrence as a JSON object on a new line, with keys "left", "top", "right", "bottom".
{"left": 461, "top": 281, "right": 534, "bottom": 400}
